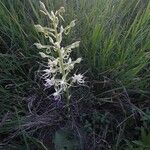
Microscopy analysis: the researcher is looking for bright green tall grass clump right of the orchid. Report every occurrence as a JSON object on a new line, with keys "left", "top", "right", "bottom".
{"left": 74, "top": 0, "right": 150, "bottom": 88}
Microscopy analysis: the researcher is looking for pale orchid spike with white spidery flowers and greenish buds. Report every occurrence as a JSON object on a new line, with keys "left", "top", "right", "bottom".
{"left": 34, "top": 1, "right": 85, "bottom": 104}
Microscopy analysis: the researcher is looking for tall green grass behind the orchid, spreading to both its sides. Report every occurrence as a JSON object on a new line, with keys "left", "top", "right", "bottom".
{"left": 0, "top": 0, "right": 150, "bottom": 89}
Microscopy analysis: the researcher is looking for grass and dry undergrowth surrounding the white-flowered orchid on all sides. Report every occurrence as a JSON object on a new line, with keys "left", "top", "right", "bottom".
{"left": 0, "top": 0, "right": 150, "bottom": 150}
